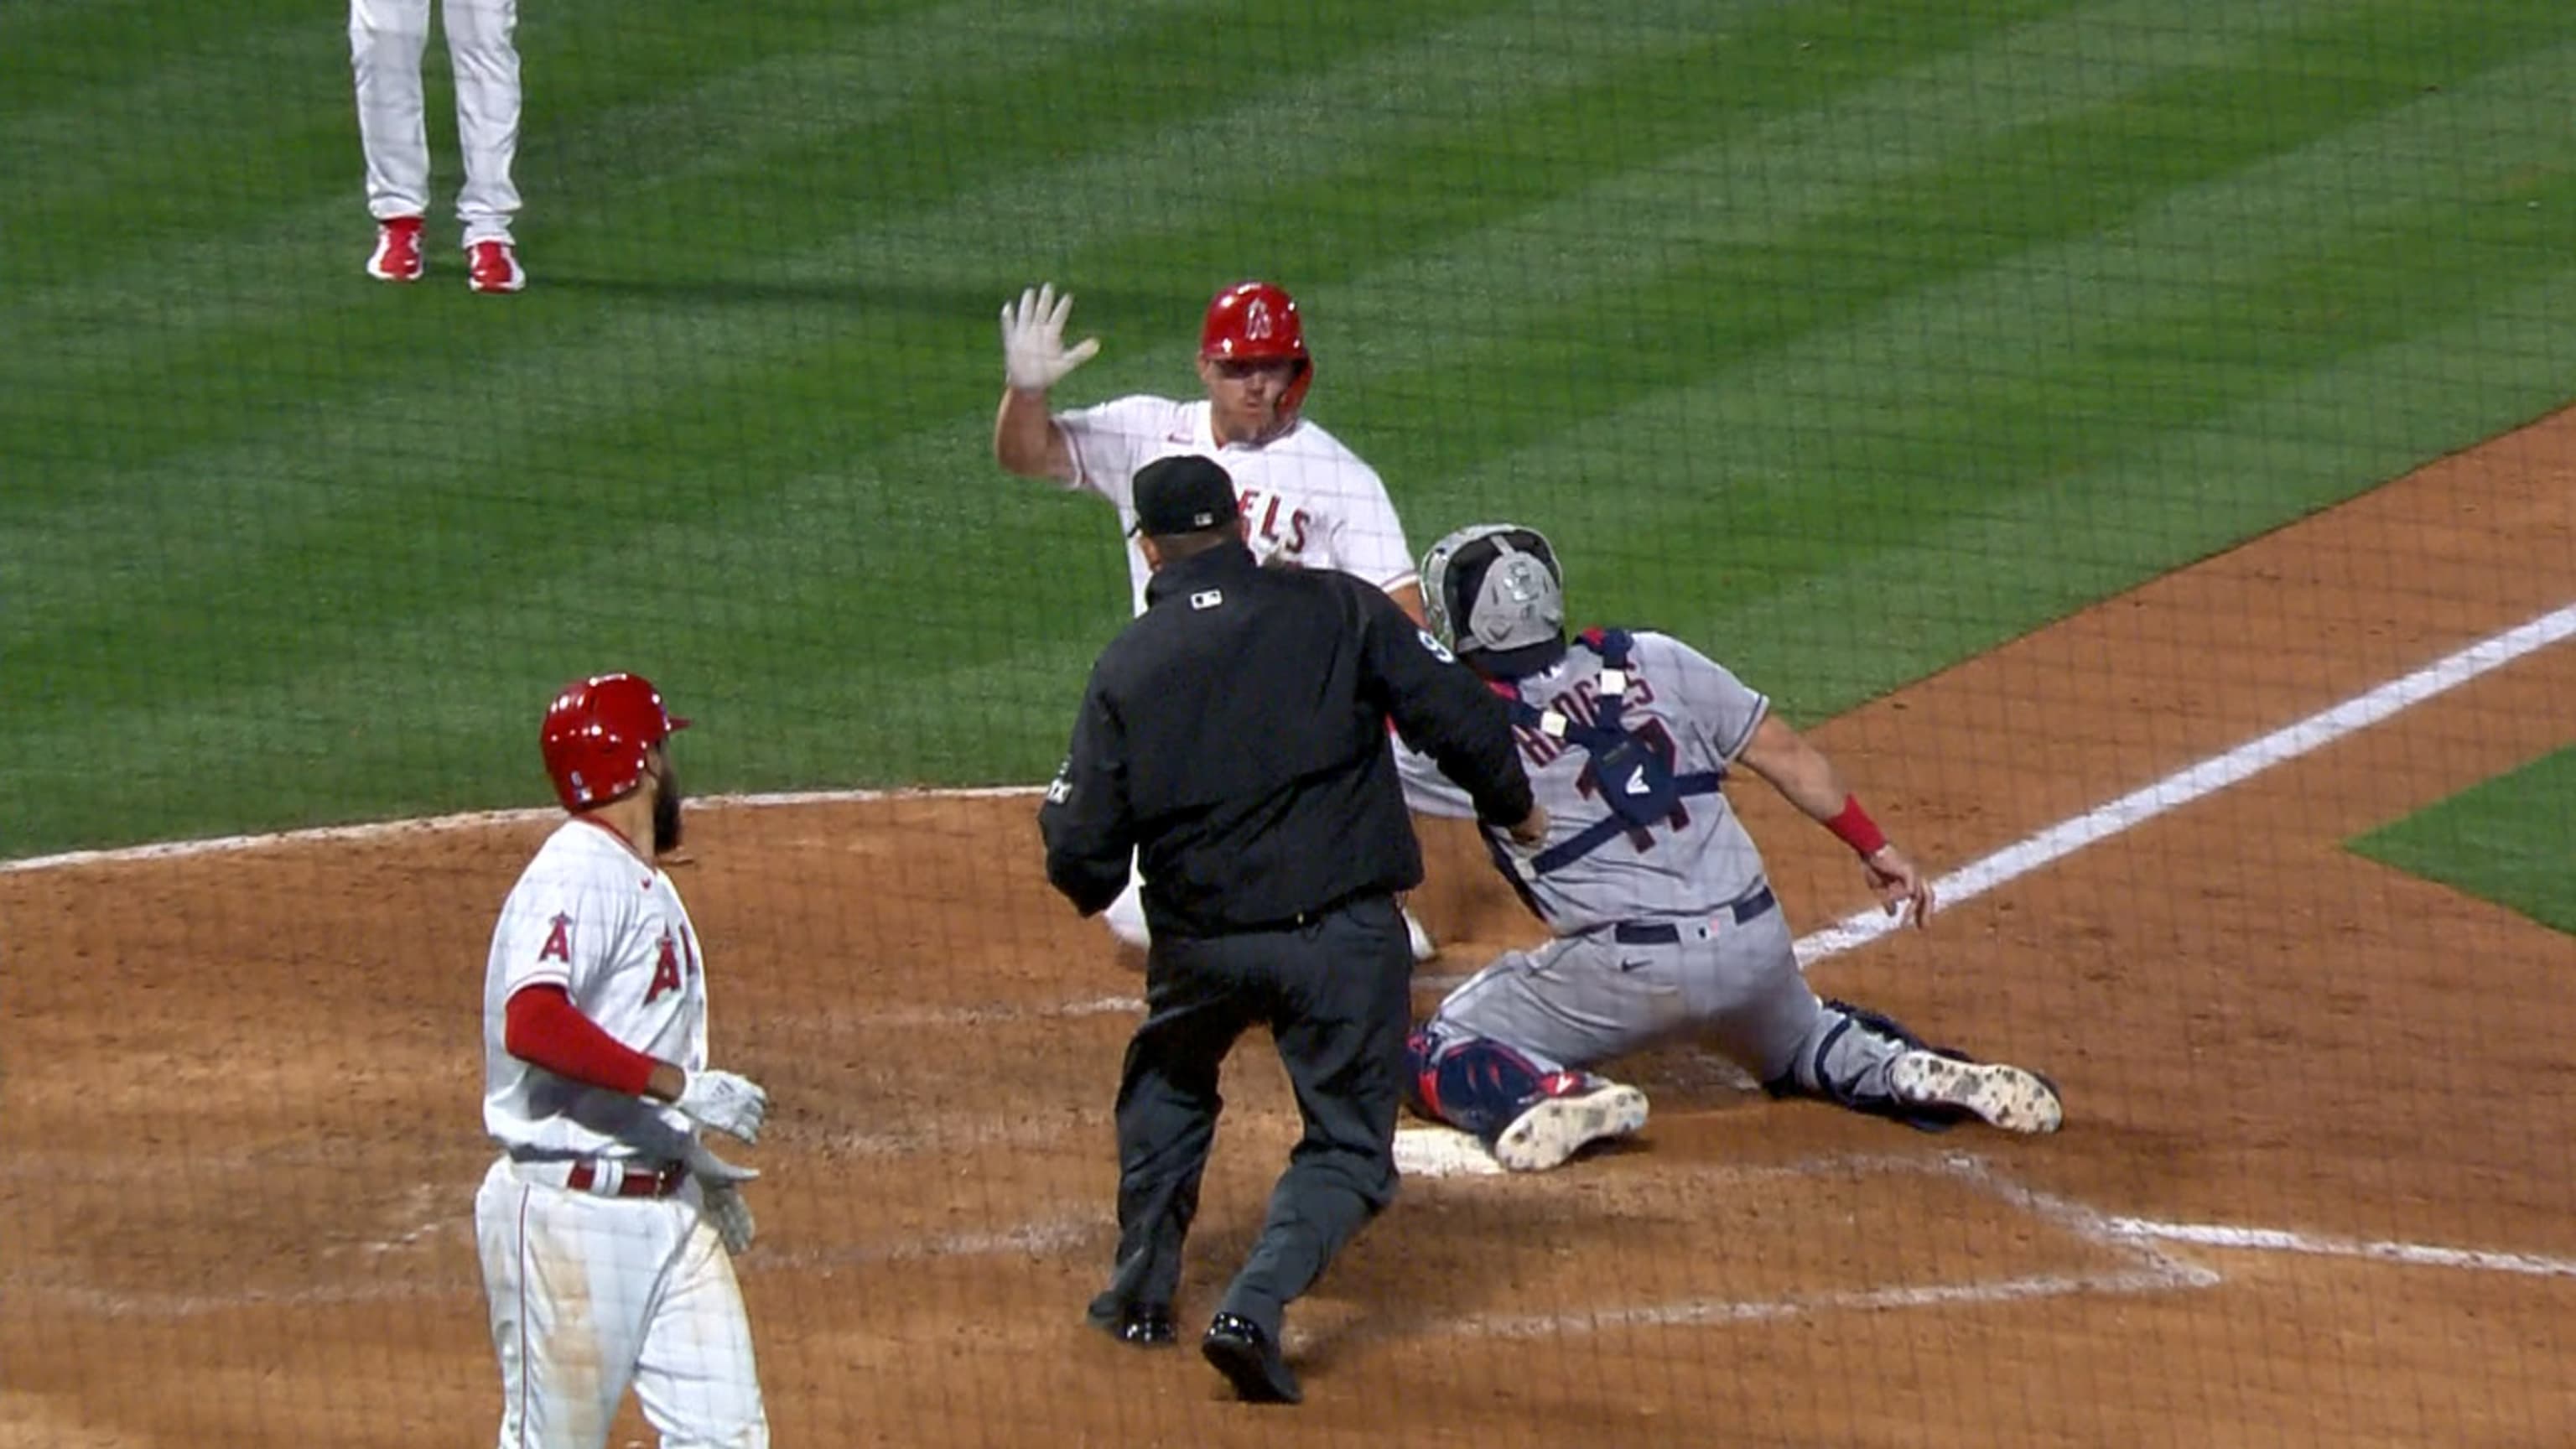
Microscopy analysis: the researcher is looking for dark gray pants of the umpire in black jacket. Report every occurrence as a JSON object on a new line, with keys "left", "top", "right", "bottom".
{"left": 1093, "top": 895, "right": 1415, "bottom": 1338}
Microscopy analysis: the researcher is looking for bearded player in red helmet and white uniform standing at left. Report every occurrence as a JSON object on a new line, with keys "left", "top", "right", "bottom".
{"left": 474, "top": 673, "right": 771, "bottom": 1449}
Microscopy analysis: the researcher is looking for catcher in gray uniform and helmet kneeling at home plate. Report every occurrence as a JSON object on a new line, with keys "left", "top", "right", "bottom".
{"left": 1399, "top": 523, "right": 2064, "bottom": 1171}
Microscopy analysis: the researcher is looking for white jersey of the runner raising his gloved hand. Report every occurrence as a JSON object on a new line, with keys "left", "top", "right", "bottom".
{"left": 1057, "top": 394, "right": 1415, "bottom": 614}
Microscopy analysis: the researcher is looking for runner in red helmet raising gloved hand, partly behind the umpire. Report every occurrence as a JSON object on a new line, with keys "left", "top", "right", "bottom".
{"left": 992, "top": 281, "right": 1435, "bottom": 962}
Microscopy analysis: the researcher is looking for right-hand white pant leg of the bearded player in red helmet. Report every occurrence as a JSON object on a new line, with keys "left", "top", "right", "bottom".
{"left": 636, "top": 1197, "right": 771, "bottom": 1449}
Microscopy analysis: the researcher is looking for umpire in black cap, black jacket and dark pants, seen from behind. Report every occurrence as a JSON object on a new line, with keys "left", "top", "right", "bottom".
{"left": 1038, "top": 456, "right": 1545, "bottom": 1403}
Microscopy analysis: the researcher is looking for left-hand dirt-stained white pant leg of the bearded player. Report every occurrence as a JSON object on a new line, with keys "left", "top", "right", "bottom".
{"left": 474, "top": 1158, "right": 654, "bottom": 1449}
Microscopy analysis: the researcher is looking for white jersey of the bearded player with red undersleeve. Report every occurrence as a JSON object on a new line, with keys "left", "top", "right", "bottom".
{"left": 485, "top": 820, "right": 706, "bottom": 1161}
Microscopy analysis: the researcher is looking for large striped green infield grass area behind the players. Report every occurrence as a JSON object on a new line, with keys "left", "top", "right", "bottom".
{"left": 0, "top": 0, "right": 2576, "bottom": 856}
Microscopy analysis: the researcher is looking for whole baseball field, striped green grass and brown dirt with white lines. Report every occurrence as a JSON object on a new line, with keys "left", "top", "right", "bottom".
{"left": 0, "top": 0, "right": 2576, "bottom": 1446}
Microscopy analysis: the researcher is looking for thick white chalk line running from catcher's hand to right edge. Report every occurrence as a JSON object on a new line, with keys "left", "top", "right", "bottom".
{"left": 1798, "top": 603, "right": 2576, "bottom": 964}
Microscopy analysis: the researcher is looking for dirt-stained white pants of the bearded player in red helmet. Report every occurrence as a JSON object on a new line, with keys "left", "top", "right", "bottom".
{"left": 474, "top": 1158, "right": 771, "bottom": 1449}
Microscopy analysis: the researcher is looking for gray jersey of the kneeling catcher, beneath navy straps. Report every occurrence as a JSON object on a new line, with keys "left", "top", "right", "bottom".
{"left": 1396, "top": 629, "right": 1769, "bottom": 936}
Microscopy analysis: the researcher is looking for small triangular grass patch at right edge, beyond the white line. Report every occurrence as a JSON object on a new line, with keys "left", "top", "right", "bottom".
{"left": 2350, "top": 745, "right": 2576, "bottom": 936}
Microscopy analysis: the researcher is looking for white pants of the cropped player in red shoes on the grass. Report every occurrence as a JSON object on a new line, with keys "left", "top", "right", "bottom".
{"left": 348, "top": 0, "right": 517, "bottom": 247}
